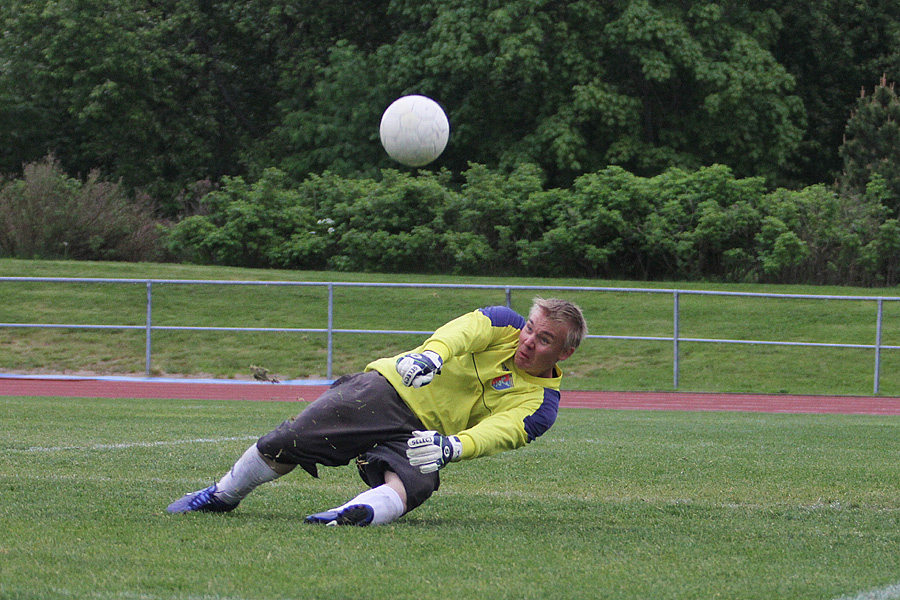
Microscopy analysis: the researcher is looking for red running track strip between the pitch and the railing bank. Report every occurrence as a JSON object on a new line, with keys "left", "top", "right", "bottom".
{"left": 0, "top": 375, "right": 900, "bottom": 415}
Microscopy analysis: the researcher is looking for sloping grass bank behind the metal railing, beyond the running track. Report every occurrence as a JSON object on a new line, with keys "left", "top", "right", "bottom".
{"left": 0, "top": 259, "right": 900, "bottom": 396}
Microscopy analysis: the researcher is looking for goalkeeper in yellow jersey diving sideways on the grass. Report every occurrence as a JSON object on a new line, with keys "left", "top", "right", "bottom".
{"left": 167, "top": 298, "right": 587, "bottom": 525}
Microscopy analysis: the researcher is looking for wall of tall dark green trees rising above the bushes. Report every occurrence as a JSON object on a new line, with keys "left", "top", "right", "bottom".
{"left": 0, "top": 0, "right": 888, "bottom": 206}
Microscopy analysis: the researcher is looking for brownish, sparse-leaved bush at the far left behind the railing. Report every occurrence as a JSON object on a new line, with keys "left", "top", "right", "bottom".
{"left": 0, "top": 156, "right": 162, "bottom": 261}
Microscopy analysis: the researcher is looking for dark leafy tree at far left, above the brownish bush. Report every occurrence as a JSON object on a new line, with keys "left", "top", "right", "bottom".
{"left": 0, "top": 0, "right": 216, "bottom": 205}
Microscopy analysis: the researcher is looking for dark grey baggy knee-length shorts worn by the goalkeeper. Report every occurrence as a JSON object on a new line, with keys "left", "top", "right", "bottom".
{"left": 256, "top": 371, "right": 440, "bottom": 511}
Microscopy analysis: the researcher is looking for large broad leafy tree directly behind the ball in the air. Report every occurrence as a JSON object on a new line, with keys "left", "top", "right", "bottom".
{"left": 272, "top": 0, "right": 803, "bottom": 185}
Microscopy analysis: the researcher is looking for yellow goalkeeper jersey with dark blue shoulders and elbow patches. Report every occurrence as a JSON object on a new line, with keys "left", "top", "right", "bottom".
{"left": 366, "top": 306, "right": 562, "bottom": 459}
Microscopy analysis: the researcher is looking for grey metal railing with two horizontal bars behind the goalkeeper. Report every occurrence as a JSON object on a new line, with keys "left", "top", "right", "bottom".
{"left": 0, "top": 277, "right": 900, "bottom": 394}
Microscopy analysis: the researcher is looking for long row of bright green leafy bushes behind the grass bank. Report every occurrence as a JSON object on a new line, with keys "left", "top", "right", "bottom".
{"left": 158, "top": 159, "right": 900, "bottom": 285}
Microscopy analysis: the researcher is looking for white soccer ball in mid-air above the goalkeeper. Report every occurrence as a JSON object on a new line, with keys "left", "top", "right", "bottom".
{"left": 379, "top": 95, "right": 450, "bottom": 167}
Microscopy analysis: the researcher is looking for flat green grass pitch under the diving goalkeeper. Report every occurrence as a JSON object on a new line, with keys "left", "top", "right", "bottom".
{"left": 0, "top": 397, "right": 900, "bottom": 600}
